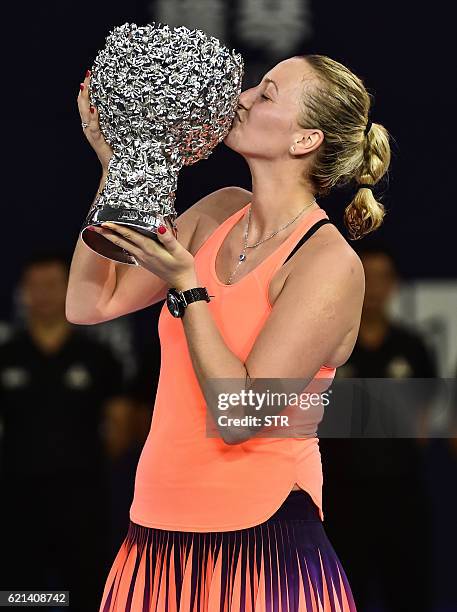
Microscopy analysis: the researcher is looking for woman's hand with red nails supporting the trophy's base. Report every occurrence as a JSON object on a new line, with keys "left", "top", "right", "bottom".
{"left": 92, "top": 222, "right": 196, "bottom": 290}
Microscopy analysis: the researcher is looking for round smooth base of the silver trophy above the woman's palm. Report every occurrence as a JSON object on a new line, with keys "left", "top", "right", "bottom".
{"left": 80, "top": 206, "right": 177, "bottom": 266}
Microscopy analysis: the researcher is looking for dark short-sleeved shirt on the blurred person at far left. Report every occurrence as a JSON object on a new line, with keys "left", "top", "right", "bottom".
{"left": 0, "top": 328, "right": 123, "bottom": 478}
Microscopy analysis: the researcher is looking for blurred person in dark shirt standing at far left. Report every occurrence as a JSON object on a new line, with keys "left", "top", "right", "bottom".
{"left": 0, "top": 253, "right": 123, "bottom": 611}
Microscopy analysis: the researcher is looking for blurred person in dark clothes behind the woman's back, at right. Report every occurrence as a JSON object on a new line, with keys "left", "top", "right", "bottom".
{"left": 320, "top": 243, "right": 437, "bottom": 612}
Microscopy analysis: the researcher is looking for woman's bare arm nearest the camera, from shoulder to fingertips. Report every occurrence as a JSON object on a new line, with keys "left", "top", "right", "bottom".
{"left": 95, "top": 224, "right": 364, "bottom": 444}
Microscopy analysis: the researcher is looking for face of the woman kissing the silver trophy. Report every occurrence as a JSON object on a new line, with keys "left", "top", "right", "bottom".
{"left": 224, "top": 57, "right": 311, "bottom": 159}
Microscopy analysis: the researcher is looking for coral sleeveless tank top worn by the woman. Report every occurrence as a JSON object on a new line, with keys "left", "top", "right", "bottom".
{"left": 130, "top": 202, "right": 336, "bottom": 532}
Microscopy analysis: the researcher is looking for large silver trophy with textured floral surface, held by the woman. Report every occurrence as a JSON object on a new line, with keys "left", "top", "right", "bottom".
{"left": 81, "top": 22, "right": 244, "bottom": 265}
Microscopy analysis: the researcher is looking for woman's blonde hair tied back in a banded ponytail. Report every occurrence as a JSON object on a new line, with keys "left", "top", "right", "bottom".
{"left": 298, "top": 55, "right": 391, "bottom": 240}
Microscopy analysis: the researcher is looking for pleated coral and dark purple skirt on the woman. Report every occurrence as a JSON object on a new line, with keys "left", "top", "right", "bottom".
{"left": 99, "top": 491, "right": 356, "bottom": 612}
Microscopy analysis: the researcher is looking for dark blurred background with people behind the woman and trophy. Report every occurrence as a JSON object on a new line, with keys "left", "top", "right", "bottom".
{"left": 0, "top": 0, "right": 457, "bottom": 612}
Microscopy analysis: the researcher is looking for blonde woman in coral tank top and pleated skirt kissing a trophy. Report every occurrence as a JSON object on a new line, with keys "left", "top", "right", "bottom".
{"left": 67, "top": 55, "right": 390, "bottom": 612}
